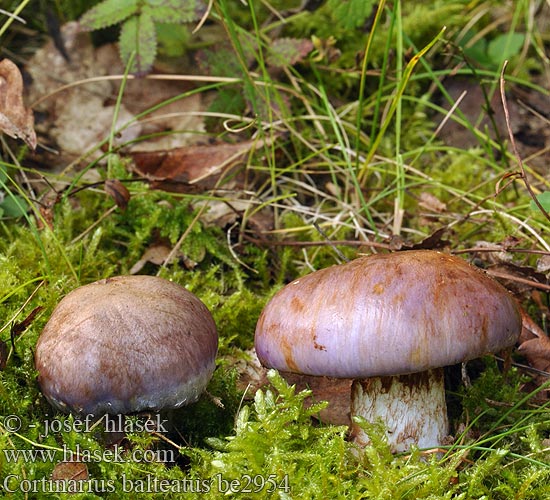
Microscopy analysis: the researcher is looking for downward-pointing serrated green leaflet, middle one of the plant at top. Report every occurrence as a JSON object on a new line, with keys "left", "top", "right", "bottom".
{"left": 120, "top": 9, "right": 157, "bottom": 74}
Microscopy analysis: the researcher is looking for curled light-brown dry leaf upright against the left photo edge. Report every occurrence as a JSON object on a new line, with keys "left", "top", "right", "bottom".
{"left": 0, "top": 59, "right": 36, "bottom": 149}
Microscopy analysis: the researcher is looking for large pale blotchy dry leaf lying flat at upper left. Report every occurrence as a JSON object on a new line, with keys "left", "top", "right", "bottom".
{"left": 27, "top": 22, "right": 204, "bottom": 168}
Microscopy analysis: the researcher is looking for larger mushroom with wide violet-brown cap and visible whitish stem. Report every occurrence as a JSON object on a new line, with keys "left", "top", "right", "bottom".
{"left": 255, "top": 250, "right": 521, "bottom": 452}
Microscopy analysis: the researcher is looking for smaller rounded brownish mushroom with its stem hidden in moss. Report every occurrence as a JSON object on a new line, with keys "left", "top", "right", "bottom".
{"left": 35, "top": 276, "right": 218, "bottom": 417}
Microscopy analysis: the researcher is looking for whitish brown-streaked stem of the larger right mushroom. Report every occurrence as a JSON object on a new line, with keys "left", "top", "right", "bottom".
{"left": 351, "top": 368, "right": 449, "bottom": 453}
